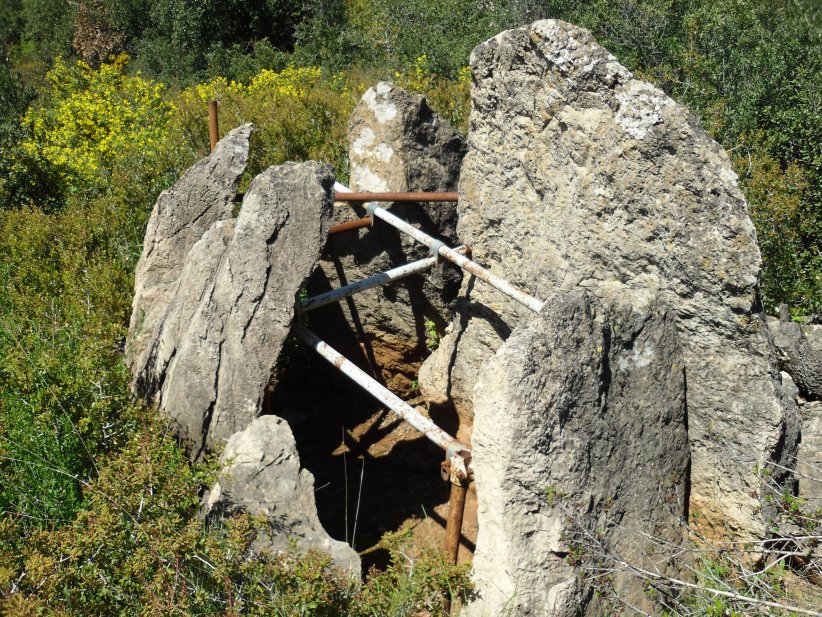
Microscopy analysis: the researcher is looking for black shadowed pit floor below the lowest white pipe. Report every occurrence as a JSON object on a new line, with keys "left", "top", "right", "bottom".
{"left": 266, "top": 324, "right": 451, "bottom": 572}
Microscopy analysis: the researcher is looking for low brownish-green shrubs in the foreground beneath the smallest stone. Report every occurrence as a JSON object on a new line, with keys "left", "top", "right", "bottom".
{"left": 0, "top": 411, "right": 468, "bottom": 617}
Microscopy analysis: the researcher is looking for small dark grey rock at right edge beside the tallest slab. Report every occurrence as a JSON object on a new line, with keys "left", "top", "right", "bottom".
{"left": 768, "top": 318, "right": 822, "bottom": 401}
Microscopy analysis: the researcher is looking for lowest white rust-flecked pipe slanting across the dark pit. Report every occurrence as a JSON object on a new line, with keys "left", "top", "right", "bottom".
{"left": 294, "top": 323, "right": 472, "bottom": 473}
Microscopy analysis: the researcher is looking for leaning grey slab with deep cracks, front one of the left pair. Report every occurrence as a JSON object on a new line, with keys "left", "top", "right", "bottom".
{"left": 130, "top": 153, "right": 334, "bottom": 457}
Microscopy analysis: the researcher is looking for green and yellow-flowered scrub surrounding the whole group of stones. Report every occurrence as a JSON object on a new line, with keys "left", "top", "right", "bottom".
{"left": 0, "top": 0, "right": 822, "bottom": 615}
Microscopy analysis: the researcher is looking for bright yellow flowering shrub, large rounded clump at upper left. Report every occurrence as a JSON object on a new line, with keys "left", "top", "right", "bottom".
{"left": 22, "top": 56, "right": 173, "bottom": 194}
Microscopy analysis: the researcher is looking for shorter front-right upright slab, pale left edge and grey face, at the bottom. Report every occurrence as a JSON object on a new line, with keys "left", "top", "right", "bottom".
{"left": 467, "top": 291, "right": 689, "bottom": 617}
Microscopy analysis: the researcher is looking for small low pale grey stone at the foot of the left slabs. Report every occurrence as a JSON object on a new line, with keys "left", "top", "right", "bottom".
{"left": 204, "top": 416, "right": 360, "bottom": 576}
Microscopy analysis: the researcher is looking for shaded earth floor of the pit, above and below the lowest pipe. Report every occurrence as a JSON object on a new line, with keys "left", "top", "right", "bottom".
{"left": 269, "top": 324, "right": 477, "bottom": 570}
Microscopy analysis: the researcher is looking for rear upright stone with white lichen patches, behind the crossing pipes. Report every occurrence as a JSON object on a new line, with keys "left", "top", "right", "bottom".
{"left": 310, "top": 83, "right": 465, "bottom": 390}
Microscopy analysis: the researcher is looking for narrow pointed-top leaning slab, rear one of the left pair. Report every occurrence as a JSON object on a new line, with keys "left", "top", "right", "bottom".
{"left": 126, "top": 124, "right": 253, "bottom": 390}
